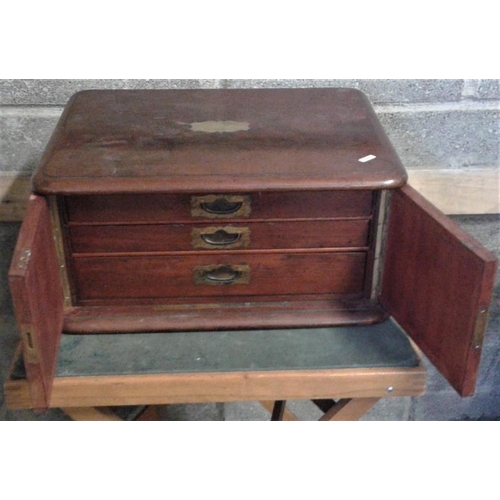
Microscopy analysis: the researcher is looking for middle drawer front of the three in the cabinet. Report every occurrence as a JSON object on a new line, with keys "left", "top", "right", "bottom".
{"left": 70, "top": 219, "right": 370, "bottom": 253}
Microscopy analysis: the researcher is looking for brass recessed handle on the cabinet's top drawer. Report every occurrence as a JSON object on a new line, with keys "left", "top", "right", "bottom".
{"left": 191, "top": 194, "right": 251, "bottom": 219}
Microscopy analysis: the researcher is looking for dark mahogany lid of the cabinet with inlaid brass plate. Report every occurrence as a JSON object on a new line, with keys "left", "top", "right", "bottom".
{"left": 34, "top": 88, "right": 406, "bottom": 194}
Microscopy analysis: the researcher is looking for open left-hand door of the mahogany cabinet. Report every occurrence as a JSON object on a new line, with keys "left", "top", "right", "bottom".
{"left": 9, "top": 195, "right": 64, "bottom": 409}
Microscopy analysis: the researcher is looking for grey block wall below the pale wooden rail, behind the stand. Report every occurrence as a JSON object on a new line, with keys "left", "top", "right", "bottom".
{"left": 0, "top": 215, "right": 500, "bottom": 421}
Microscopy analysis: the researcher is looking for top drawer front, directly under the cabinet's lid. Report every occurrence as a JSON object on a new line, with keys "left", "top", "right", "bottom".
{"left": 66, "top": 191, "right": 373, "bottom": 223}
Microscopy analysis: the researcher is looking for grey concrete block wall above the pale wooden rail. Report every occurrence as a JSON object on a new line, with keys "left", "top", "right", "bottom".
{"left": 0, "top": 80, "right": 500, "bottom": 174}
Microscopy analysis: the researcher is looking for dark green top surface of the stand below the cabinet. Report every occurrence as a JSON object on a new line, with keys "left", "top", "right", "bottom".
{"left": 11, "top": 320, "right": 418, "bottom": 378}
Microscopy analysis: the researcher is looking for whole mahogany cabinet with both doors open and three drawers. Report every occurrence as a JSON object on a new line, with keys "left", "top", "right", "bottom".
{"left": 10, "top": 89, "right": 496, "bottom": 407}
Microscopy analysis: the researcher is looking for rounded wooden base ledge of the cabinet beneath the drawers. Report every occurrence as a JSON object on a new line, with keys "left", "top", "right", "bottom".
{"left": 64, "top": 295, "right": 387, "bottom": 333}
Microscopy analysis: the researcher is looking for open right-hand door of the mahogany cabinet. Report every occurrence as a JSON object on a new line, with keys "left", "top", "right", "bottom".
{"left": 380, "top": 186, "right": 496, "bottom": 396}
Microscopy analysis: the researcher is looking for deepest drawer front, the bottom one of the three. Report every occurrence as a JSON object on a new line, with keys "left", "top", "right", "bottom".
{"left": 74, "top": 252, "right": 366, "bottom": 300}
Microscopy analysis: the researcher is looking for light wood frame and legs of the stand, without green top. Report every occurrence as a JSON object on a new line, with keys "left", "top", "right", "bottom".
{"left": 4, "top": 342, "right": 426, "bottom": 420}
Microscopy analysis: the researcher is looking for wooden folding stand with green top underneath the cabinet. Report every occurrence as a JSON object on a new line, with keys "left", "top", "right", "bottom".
{"left": 5, "top": 320, "right": 426, "bottom": 420}
